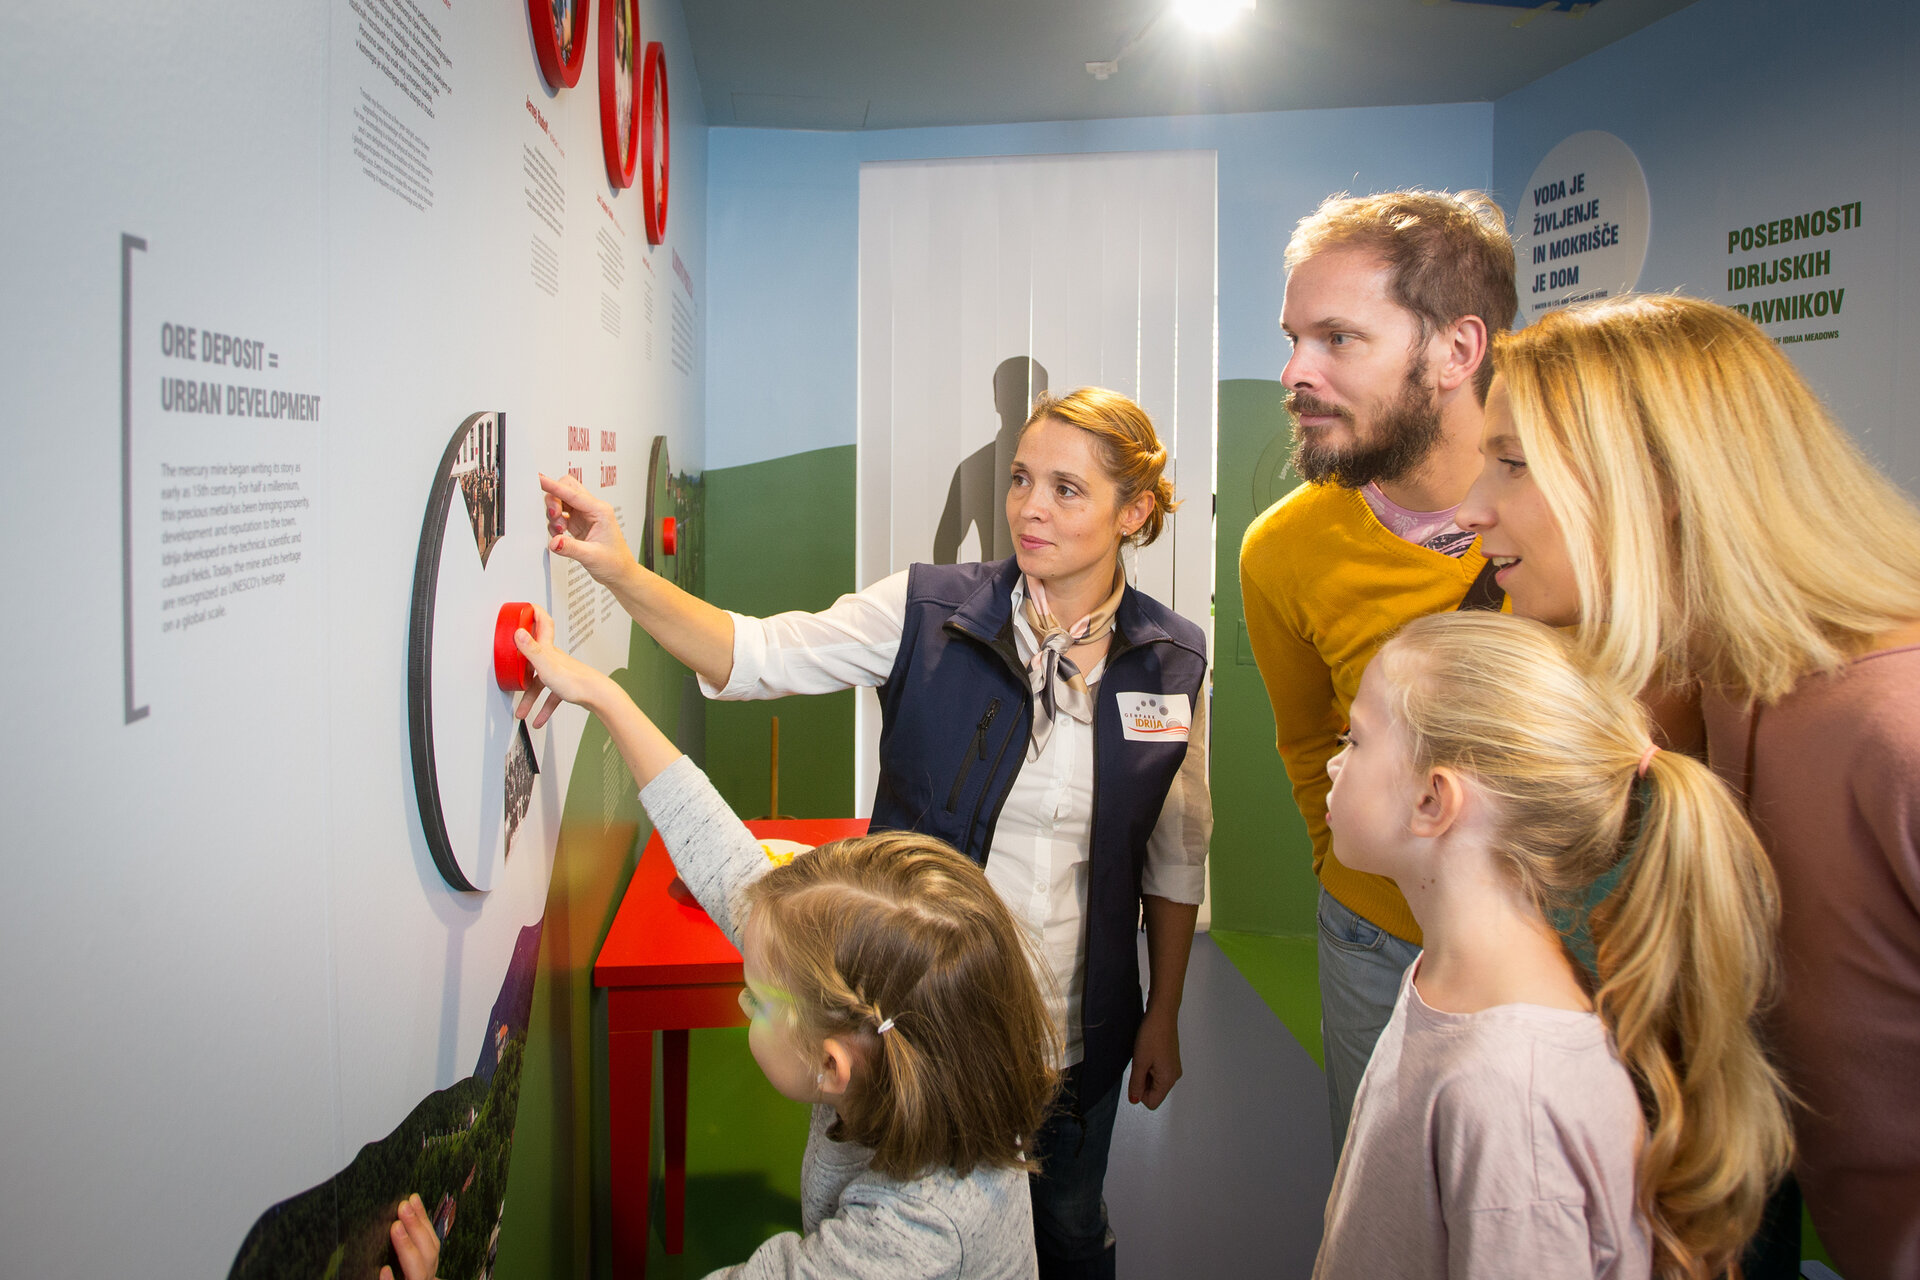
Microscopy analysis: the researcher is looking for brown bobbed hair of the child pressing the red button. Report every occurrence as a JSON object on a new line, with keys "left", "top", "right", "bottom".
{"left": 747, "top": 831, "right": 1060, "bottom": 1180}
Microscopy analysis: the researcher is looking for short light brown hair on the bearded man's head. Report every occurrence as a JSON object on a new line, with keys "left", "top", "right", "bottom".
{"left": 1286, "top": 190, "right": 1521, "bottom": 401}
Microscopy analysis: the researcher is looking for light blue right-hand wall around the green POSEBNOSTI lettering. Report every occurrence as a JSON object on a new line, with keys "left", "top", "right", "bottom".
{"left": 1494, "top": 0, "right": 1920, "bottom": 487}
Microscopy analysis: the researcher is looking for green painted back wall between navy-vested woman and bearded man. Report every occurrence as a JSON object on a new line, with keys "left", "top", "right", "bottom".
{"left": 1212, "top": 378, "right": 1319, "bottom": 936}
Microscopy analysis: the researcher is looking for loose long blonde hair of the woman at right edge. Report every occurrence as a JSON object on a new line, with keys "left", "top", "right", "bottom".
{"left": 1494, "top": 294, "right": 1920, "bottom": 702}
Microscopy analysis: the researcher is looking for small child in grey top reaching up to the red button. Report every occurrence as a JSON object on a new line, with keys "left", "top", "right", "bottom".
{"left": 515, "top": 610, "right": 1058, "bottom": 1280}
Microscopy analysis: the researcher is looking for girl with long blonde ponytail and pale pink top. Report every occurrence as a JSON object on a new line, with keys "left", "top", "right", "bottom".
{"left": 1315, "top": 612, "right": 1789, "bottom": 1280}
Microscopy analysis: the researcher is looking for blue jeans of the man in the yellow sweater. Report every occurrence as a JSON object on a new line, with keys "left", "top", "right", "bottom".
{"left": 1319, "top": 889, "right": 1421, "bottom": 1159}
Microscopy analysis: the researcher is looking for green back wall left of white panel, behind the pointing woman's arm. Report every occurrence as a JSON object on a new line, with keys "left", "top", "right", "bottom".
{"left": 705, "top": 445, "right": 862, "bottom": 818}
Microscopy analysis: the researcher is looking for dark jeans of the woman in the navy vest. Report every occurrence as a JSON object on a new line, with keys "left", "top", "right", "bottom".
{"left": 1027, "top": 1067, "right": 1125, "bottom": 1280}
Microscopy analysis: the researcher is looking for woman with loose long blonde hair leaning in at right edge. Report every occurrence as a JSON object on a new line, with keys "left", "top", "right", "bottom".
{"left": 1461, "top": 296, "right": 1920, "bottom": 1280}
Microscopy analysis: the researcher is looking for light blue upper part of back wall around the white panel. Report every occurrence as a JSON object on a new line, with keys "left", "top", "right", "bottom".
{"left": 707, "top": 104, "right": 1497, "bottom": 466}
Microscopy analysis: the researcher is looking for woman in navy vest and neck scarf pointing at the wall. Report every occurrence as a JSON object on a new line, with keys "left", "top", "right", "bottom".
{"left": 541, "top": 388, "right": 1213, "bottom": 1280}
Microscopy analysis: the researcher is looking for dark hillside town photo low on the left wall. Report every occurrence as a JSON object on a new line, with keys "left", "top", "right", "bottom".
{"left": 227, "top": 923, "right": 541, "bottom": 1280}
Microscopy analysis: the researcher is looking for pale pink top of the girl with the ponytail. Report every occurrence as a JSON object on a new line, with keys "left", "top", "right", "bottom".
{"left": 1313, "top": 961, "right": 1651, "bottom": 1280}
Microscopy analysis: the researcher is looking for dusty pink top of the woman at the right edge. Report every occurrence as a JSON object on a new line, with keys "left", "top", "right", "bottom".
{"left": 1703, "top": 645, "right": 1920, "bottom": 1280}
